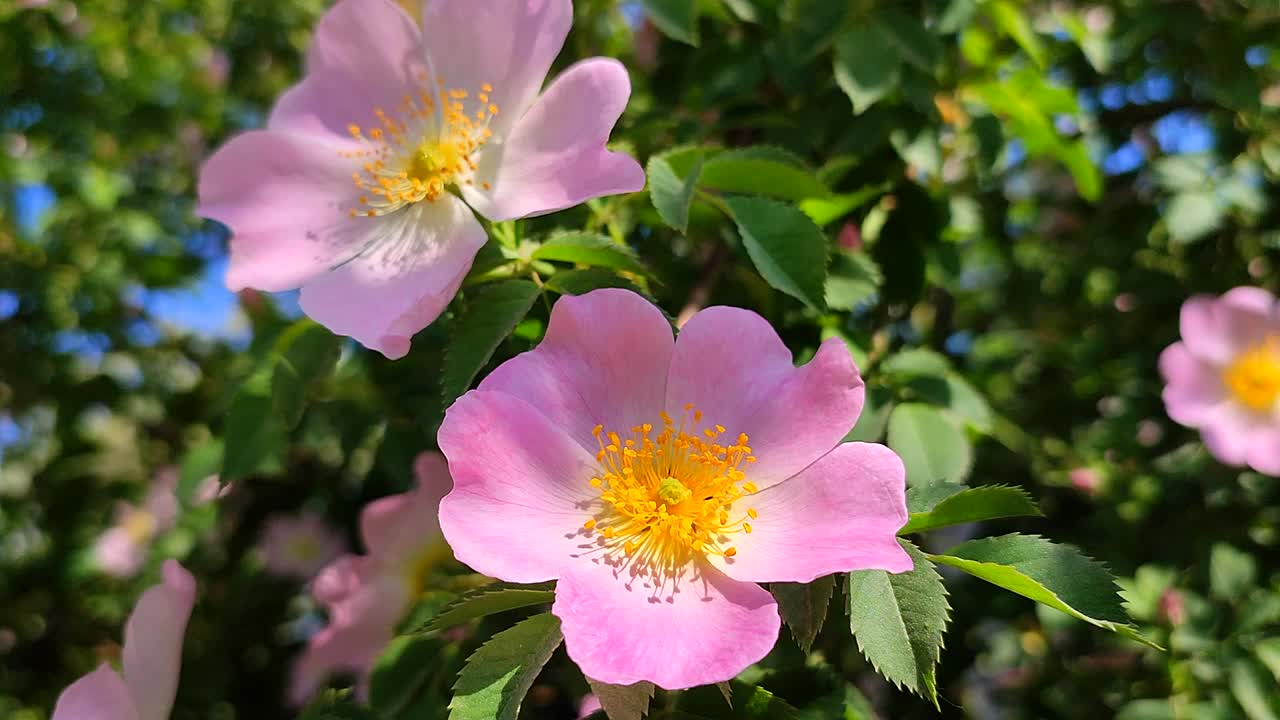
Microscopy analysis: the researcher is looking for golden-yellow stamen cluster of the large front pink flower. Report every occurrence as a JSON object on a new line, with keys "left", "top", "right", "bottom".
{"left": 582, "top": 405, "right": 759, "bottom": 578}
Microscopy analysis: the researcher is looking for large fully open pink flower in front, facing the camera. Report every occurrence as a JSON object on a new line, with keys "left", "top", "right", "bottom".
{"left": 439, "top": 290, "right": 911, "bottom": 689}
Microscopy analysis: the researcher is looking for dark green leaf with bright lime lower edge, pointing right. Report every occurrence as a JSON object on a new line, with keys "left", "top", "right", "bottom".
{"left": 929, "top": 534, "right": 1160, "bottom": 648}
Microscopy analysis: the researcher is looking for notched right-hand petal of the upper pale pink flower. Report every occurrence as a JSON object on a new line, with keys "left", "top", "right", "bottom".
{"left": 462, "top": 58, "right": 644, "bottom": 220}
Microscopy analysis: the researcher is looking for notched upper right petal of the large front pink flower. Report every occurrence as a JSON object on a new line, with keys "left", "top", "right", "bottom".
{"left": 667, "top": 307, "right": 864, "bottom": 488}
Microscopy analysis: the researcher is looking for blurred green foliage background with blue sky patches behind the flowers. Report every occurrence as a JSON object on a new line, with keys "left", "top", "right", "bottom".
{"left": 0, "top": 0, "right": 1280, "bottom": 720}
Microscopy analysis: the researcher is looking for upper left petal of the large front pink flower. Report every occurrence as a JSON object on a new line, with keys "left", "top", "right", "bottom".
{"left": 478, "top": 290, "right": 675, "bottom": 450}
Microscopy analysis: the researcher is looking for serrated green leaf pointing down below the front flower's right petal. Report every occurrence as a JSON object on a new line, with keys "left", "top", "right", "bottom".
{"left": 849, "top": 541, "right": 951, "bottom": 707}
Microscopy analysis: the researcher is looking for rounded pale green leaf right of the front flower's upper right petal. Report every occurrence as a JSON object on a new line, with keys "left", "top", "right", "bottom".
{"left": 888, "top": 402, "right": 973, "bottom": 487}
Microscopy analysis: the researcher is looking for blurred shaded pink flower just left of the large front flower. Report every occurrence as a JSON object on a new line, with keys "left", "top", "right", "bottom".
{"left": 289, "top": 452, "right": 452, "bottom": 705}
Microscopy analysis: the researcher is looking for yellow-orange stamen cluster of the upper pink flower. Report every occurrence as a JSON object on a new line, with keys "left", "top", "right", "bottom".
{"left": 340, "top": 74, "right": 498, "bottom": 218}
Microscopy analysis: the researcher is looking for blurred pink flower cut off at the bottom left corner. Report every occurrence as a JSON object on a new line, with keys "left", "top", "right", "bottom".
{"left": 52, "top": 560, "right": 196, "bottom": 720}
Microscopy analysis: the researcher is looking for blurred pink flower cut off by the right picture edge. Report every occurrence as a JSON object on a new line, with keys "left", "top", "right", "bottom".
{"left": 1160, "top": 287, "right": 1280, "bottom": 475}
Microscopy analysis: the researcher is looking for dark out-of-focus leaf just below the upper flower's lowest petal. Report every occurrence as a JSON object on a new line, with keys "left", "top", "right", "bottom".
{"left": 271, "top": 322, "right": 343, "bottom": 429}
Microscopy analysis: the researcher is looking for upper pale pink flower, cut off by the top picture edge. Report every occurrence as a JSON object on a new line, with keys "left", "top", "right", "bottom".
{"left": 200, "top": 0, "right": 644, "bottom": 359}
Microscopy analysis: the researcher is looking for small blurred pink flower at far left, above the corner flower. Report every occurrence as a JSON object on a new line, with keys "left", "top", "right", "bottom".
{"left": 93, "top": 466, "right": 178, "bottom": 578}
